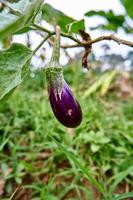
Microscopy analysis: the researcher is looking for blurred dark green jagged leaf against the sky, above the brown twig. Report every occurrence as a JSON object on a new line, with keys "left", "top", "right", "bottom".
{"left": 85, "top": 10, "right": 125, "bottom": 31}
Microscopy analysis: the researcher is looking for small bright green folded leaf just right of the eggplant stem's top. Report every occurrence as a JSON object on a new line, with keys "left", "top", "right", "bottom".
{"left": 66, "top": 19, "right": 85, "bottom": 33}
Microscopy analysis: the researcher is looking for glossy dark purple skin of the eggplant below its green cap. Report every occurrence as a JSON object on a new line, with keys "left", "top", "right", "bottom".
{"left": 48, "top": 82, "right": 82, "bottom": 128}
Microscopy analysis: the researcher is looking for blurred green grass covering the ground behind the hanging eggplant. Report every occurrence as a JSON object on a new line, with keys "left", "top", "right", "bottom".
{"left": 0, "top": 61, "right": 133, "bottom": 200}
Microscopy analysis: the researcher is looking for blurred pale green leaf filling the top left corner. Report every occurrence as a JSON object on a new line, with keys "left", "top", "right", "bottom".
{"left": 0, "top": 0, "right": 42, "bottom": 39}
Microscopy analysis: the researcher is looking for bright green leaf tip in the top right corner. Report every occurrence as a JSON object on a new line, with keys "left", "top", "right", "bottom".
{"left": 121, "top": 0, "right": 133, "bottom": 18}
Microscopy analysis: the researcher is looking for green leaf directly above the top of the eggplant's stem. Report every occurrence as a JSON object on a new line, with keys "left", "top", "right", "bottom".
{"left": 42, "top": 3, "right": 75, "bottom": 32}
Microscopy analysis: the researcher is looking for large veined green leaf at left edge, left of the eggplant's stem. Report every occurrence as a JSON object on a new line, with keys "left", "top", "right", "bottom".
{"left": 0, "top": 44, "right": 32, "bottom": 100}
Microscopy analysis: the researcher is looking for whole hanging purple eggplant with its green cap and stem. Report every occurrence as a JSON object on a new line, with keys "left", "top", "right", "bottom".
{"left": 46, "top": 26, "right": 82, "bottom": 128}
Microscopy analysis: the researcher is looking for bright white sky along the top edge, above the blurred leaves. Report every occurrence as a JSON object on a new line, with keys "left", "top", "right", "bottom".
{"left": 45, "top": 0, "right": 124, "bottom": 19}
